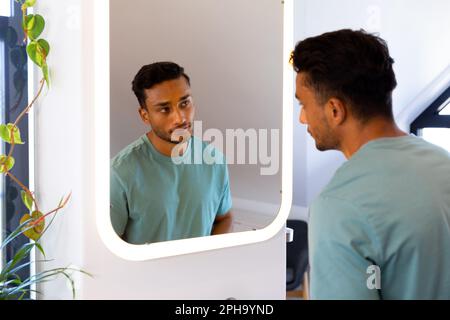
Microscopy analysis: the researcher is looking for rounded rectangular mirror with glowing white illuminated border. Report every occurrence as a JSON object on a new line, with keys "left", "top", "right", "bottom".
{"left": 95, "top": 0, "right": 293, "bottom": 260}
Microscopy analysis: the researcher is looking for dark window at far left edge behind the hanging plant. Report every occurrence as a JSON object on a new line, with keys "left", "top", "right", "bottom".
{"left": 0, "top": 0, "right": 30, "bottom": 279}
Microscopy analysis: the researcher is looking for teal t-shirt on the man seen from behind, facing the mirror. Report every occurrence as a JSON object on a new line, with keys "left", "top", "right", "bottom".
{"left": 309, "top": 135, "right": 450, "bottom": 299}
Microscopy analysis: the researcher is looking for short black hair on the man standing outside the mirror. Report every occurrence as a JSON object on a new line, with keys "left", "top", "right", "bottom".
{"left": 291, "top": 29, "right": 397, "bottom": 121}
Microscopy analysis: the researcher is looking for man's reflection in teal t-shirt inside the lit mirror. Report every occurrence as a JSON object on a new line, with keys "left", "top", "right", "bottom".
{"left": 111, "top": 62, "right": 232, "bottom": 244}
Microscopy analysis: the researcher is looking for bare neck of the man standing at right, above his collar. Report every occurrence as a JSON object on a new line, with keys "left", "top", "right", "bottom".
{"left": 339, "top": 118, "right": 408, "bottom": 159}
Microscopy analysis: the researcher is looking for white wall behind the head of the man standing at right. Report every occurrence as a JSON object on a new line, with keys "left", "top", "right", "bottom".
{"left": 294, "top": 0, "right": 450, "bottom": 206}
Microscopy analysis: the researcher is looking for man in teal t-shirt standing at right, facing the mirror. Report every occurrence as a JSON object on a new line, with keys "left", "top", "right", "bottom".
{"left": 292, "top": 30, "right": 450, "bottom": 299}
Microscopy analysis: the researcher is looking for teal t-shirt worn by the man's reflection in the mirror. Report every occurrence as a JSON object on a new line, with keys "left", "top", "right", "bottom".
{"left": 110, "top": 135, "right": 232, "bottom": 244}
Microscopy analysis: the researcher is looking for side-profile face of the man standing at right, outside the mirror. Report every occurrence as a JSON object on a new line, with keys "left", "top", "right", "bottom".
{"left": 295, "top": 72, "right": 338, "bottom": 151}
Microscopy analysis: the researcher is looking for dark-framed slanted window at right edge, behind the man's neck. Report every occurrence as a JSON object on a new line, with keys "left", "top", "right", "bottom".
{"left": 411, "top": 87, "right": 450, "bottom": 152}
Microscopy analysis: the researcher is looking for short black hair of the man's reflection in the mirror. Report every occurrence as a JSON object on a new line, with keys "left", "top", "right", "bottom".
{"left": 132, "top": 61, "right": 191, "bottom": 108}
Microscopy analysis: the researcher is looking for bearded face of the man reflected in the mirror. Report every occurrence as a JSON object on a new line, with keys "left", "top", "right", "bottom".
{"left": 139, "top": 77, "right": 195, "bottom": 144}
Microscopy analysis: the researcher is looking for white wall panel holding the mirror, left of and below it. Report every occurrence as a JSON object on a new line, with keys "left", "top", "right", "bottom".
{"left": 35, "top": 0, "right": 285, "bottom": 299}
